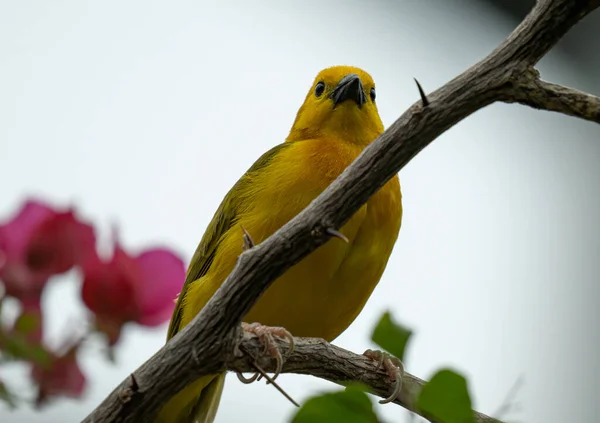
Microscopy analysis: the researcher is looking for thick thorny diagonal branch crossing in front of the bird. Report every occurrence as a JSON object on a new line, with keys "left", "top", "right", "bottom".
{"left": 84, "top": 0, "right": 600, "bottom": 423}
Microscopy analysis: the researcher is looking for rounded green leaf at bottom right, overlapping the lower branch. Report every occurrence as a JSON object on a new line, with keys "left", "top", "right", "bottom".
{"left": 417, "top": 369, "right": 474, "bottom": 423}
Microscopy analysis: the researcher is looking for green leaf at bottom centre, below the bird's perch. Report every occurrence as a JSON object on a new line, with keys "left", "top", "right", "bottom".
{"left": 292, "top": 386, "right": 379, "bottom": 423}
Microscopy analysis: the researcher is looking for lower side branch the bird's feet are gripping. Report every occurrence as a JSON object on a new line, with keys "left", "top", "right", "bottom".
{"left": 227, "top": 333, "right": 498, "bottom": 423}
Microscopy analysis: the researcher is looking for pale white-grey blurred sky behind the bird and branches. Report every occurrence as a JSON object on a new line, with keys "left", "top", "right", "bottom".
{"left": 0, "top": 0, "right": 600, "bottom": 423}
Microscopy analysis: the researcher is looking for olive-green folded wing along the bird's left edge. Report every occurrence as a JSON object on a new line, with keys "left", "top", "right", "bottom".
{"left": 167, "top": 143, "right": 291, "bottom": 339}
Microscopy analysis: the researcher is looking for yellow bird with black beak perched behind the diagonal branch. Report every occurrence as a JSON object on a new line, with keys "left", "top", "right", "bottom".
{"left": 157, "top": 66, "right": 402, "bottom": 423}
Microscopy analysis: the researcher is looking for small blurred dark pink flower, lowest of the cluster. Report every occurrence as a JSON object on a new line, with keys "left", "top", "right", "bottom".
{"left": 31, "top": 342, "right": 86, "bottom": 407}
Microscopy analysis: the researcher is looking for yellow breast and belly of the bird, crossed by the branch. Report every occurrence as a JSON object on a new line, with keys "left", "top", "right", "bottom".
{"left": 182, "top": 140, "right": 402, "bottom": 340}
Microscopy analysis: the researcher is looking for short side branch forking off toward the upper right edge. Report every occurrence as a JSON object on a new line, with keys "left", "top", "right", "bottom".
{"left": 506, "top": 68, "right": 600, "bottom": 123}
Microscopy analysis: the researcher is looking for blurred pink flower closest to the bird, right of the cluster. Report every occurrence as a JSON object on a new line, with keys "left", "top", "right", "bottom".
{"left": 81, "top": 244, "right": 185, "bottom": 345}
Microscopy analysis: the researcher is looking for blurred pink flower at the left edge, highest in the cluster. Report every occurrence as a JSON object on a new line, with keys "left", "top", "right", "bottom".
{"left": 0, "top": 200, "right": 96, "bottom": 304}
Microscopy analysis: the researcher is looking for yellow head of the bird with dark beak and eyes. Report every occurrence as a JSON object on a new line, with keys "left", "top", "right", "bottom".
{"left": 287, "top": 66, "right": 383, "bottom": 145}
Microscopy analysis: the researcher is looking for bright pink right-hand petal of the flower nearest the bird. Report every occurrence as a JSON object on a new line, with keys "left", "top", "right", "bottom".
{"left": 136, "top": 249, "right": 185, "bottom": 326}
